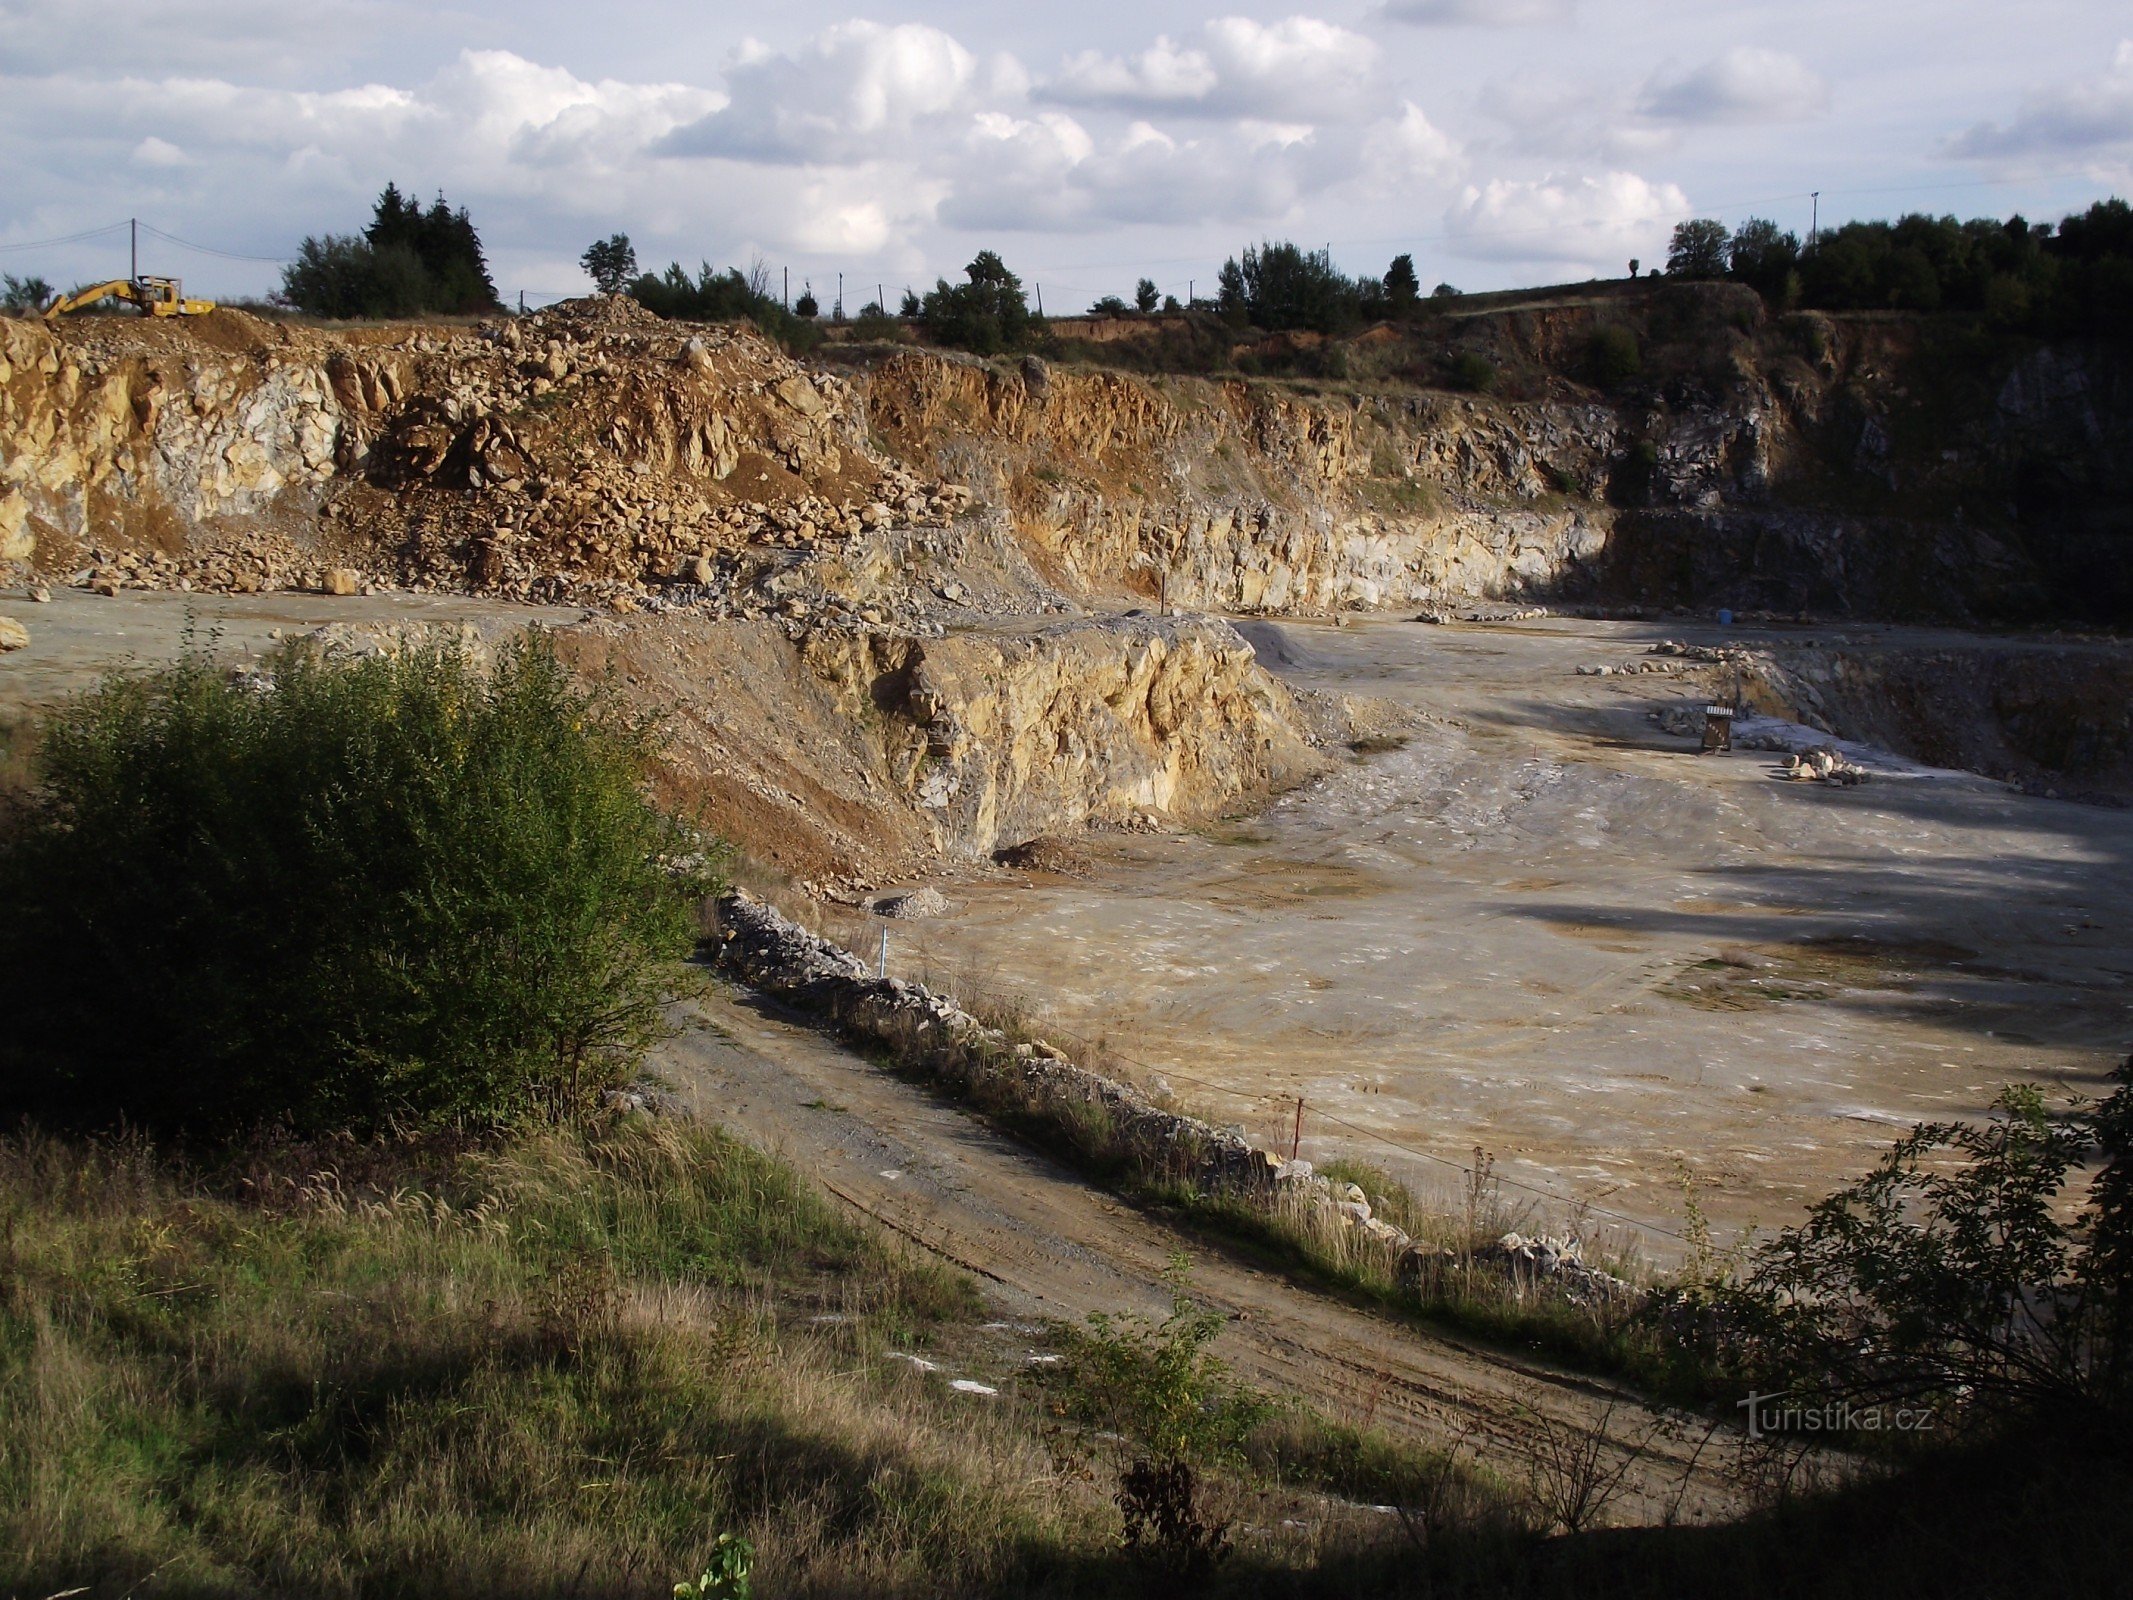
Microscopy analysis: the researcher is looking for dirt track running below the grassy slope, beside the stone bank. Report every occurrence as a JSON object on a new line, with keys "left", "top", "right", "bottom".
{"left": 651, "top": 994, "right": 1743, "bottom": 1521}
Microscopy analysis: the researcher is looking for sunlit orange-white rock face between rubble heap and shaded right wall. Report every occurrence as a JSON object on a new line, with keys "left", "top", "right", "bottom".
{"left": 866, "top": 354, "right": 1621, "bottom": 612}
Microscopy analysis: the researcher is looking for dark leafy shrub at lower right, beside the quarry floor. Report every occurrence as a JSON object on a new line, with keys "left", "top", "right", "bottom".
{"left": 1677, "top": 1058, "right": 2133, "bottom": 1423}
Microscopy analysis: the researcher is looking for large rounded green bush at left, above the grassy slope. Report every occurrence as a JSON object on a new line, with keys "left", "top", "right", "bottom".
{"left": 0, "top": 638, "right": 706, "bottom": 1135}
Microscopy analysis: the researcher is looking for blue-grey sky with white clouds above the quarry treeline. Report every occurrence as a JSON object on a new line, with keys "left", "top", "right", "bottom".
{"left": 0, "top": 0, "right": 2133, "bottom": 311}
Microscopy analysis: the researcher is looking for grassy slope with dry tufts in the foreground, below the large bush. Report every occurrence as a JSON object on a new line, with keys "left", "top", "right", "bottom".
{"left": 0, "top": 1120, "right": 1523, "bottom": 1598}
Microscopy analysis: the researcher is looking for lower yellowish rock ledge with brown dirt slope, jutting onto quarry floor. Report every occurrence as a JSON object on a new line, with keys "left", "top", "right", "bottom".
{"left": 559, "top": 614, "right": 1322, "bottom": 890}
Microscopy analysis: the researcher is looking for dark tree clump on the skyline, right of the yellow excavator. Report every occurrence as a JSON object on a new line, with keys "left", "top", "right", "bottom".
{"left": 282, "top": 183, "right": 497, "bottom": 318}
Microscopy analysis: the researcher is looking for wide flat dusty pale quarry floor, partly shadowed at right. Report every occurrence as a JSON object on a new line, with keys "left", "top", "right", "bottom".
{"left": 874, "top": 619, "right": 2133, "bottom": 1257}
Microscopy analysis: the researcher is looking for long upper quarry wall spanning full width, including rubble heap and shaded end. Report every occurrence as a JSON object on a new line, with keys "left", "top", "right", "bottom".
{"left": 0, "top": 286, "right": 2133, "bottom": 623}
